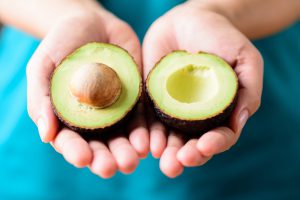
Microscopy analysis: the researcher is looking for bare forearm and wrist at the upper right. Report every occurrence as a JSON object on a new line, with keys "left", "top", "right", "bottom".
{"left": 187, "top": 0, "right": 300, "bottom": 39}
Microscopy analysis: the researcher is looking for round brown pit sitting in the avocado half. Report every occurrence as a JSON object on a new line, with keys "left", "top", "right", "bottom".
{"left": 69, "top": 63, "right": 122, "bottom": 108}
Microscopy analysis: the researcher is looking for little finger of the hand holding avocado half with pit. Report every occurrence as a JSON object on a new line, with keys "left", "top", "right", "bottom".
{"left": 129, "top": 103, "right": 150, "bottom": 158}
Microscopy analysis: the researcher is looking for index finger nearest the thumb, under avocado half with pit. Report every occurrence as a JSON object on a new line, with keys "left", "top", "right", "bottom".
{"left": 53, "top": 128, "right": 93, "bottom": 167}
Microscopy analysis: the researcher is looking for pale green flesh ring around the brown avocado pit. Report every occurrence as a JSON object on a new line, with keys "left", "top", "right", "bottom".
{"left": 50, "top": 43, "right": 141, "bottom": 130}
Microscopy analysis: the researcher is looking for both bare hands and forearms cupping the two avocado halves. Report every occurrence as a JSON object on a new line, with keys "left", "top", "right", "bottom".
{"left": 0, "top": 0, "right": 300, "bottom": 178}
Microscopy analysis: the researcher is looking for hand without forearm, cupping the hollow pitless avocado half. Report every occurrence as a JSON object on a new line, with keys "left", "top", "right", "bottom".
{"left": 143, "top": 1, "right": 263, "bottom": 177}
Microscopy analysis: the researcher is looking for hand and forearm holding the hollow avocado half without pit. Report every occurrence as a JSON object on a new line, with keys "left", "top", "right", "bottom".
{"left": 143, "top": 0, "right": 300, "bottom": 178}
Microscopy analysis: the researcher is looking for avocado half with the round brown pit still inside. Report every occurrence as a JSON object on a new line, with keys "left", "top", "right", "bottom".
{"left": 50, "top": 43, "right": 141, "bottom": 133}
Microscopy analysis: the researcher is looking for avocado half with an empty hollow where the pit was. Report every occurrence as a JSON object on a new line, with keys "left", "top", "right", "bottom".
{"left": 146, "top": 51, "right": 238, "bottom": 135}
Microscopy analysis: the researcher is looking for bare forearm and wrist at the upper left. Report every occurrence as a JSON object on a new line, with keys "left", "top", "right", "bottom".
{"left": 0, "top": 0, "right": 105, "bottom": 38}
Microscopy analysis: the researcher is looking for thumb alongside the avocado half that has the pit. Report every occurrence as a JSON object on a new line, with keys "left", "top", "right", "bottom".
{"left": 26, "top": 45, "right": 59, "bottom": 142}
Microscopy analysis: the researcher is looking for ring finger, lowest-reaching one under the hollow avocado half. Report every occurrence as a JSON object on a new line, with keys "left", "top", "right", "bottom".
{"left": 160, "top": 133, "right": 183, "bottom": 178}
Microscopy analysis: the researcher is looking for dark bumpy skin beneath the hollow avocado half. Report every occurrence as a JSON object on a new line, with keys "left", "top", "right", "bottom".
{"left": 145, "top": 84, "right": 237, "bottom": 137}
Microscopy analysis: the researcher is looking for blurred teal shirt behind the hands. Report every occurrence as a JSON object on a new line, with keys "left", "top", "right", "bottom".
{"left": 0, "top": 0, "right": 300, "bottom": 200}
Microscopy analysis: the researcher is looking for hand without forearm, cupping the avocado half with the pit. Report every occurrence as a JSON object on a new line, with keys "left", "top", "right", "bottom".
{"left": 27, "top": 8, "right": 149, "bottom": 178}
